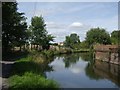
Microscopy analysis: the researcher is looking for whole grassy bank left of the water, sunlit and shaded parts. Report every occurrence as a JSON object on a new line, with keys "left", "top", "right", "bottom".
{"left": 8, "top": 52, "right": 59, "bottom": 90}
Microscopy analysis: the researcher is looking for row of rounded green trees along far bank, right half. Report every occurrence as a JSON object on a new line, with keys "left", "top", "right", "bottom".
{"left": 64, "top": 27, "right": 120, "bottom": 49}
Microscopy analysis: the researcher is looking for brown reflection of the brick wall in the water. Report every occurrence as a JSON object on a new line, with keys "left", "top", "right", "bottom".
{"left": 93, "top": 61, "right": 120, "bottom": 87}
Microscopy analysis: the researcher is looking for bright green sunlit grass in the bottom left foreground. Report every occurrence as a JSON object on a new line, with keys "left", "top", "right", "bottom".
{"left": 9, "top": 72, "right": 58, "bottom": 90}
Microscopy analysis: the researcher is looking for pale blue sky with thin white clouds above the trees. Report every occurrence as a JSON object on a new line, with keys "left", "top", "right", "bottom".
{"left": 18, "top": 2, "right": 118, "bottom": 42}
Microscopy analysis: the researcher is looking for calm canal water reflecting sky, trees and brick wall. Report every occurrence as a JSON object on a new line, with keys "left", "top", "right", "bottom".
{"left": 46, "top": 53, "right": 120, "bottom": 88}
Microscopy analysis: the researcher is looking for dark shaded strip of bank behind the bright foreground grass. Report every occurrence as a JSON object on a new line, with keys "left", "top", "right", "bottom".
{"left": 11, "top": 61, "right": 53, "bottom": 76}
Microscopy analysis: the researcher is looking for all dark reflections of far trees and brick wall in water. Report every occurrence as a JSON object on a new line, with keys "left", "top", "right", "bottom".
{"left": 56, "top": 53, "right": 120, "bottom": 86}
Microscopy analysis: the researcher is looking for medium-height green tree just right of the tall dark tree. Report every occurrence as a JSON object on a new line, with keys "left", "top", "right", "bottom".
{"left": 30, "top": 16, "right": 54, "bottom": 49}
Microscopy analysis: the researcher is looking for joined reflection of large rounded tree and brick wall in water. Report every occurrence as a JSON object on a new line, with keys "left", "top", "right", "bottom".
{"left": 80, "top": 53, "right": 120, "bottom": 86}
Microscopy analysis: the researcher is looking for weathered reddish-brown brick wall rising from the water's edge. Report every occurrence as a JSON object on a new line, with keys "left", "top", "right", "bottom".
{"left": 94, "top": 45, "right": 120, "bottom": 65}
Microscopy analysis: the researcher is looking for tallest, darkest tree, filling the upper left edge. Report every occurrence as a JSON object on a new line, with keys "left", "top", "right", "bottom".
{"left": 2, "top": 2, "right": 27, "bottom": 52}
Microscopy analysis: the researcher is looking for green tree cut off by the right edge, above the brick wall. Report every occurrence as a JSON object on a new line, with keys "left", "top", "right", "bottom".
{"left": 111, "top": 30, "right": 120, "bottom": 44}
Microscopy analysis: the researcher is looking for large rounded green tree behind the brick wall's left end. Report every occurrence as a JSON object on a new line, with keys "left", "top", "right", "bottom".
{"left": 86, "top": 27, "right": 111, "bottom": 46}
